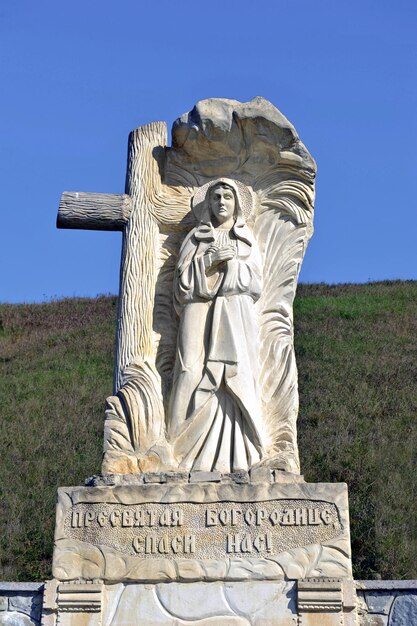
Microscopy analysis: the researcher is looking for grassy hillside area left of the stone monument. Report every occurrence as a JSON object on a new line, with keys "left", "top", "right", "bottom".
{"left": 0, "top": 298, "right": 116, "bottom": 580}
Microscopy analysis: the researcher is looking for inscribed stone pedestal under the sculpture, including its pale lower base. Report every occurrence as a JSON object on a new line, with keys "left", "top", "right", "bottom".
{"left": 44, "top": 470, "right": 355, "bottom": 626}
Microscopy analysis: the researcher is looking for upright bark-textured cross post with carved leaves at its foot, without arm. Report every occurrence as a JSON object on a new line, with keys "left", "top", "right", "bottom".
{"left": 102, "top": 122, "right": 169, "bottom": 474}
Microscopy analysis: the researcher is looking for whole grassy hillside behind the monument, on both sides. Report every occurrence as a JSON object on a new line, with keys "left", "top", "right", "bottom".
{"left": 0, "top": 282, "right": 417, "bottom": 580}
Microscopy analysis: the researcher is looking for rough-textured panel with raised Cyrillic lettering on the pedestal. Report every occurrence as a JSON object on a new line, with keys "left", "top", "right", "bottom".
{"left": 64, "top": 500, "right": 342, "bottom": 559}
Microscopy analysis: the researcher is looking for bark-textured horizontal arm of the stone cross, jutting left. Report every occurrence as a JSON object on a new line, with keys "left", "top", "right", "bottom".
{"left": 56, "top": 191, "right": 132, "bottom": 230}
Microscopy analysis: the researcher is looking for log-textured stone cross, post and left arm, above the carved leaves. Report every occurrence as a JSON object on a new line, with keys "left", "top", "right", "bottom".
{"left": 57, "top": 122, "right": 185, "bottom": 393}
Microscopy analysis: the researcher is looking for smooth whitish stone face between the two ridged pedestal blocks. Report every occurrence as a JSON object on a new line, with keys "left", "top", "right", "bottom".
{"left": 103, "top": 582, "right": 297, "bottom": 626}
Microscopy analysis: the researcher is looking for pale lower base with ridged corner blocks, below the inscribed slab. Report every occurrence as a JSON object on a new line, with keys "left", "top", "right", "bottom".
{"left": 42, "top": 579, "right": 357, "bottom": 626}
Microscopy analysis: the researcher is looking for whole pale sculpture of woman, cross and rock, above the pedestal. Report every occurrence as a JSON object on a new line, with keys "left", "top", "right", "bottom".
{"left": 58, "top": 98, "right": 316, "bottom": 474}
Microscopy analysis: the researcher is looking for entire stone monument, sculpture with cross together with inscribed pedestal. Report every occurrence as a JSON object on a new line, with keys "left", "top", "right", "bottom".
{"left": 43, "top": 97, "right": 355, "bottom": 626}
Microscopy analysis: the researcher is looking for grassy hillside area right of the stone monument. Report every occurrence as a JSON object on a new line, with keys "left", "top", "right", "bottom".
{"left": 295, "top": 281, "right": 417, "bottom": 578}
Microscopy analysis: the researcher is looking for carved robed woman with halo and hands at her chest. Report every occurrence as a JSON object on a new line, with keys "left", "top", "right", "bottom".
{"left": 168, "top": 179, "right": 263, "bottom": 472}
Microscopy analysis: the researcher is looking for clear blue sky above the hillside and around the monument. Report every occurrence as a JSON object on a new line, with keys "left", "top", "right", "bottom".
{"left": 0, "top": 0, "right": 417, "bottom": 302}
